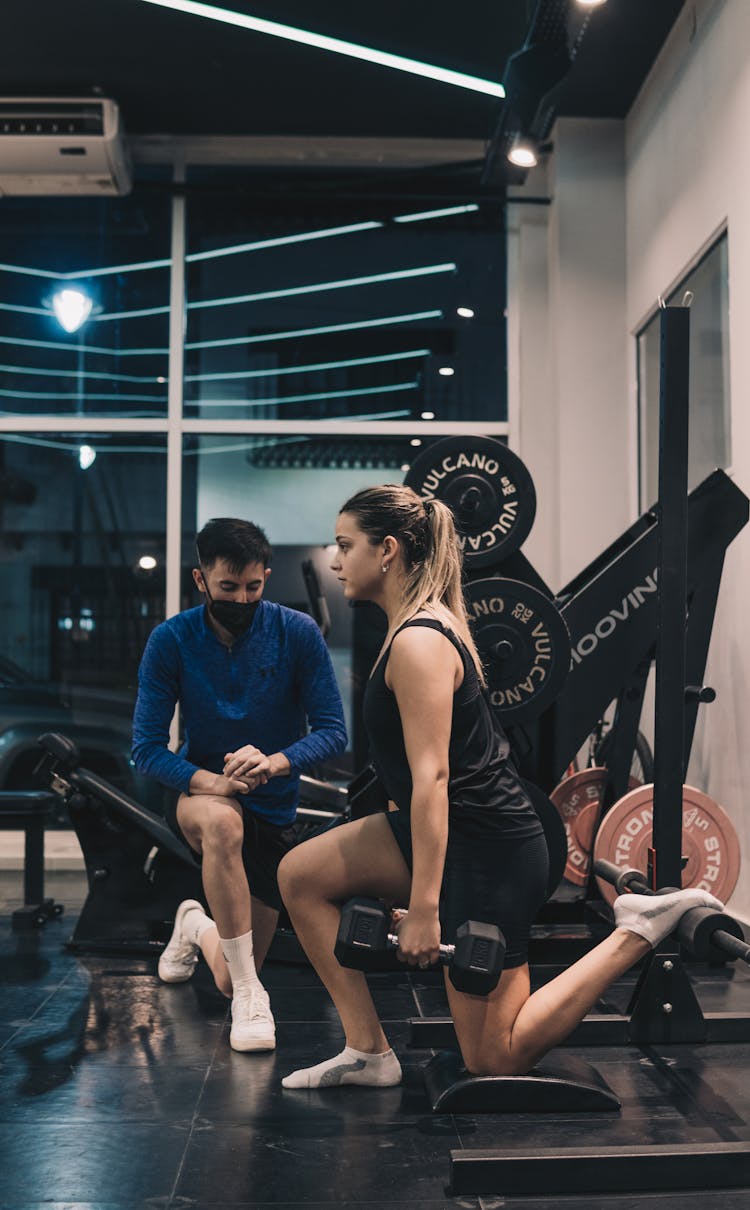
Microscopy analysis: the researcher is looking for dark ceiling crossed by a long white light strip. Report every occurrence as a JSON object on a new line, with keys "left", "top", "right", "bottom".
{"left": 0, "top": 0, "right": 683, "bottom": 139}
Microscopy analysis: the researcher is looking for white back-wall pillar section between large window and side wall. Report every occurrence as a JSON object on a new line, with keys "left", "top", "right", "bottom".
{"left": 508, "top": 119, "right": 635, "bottom": 590}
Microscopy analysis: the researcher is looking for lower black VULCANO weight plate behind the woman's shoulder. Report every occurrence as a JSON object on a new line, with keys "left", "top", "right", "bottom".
{"left": 463, "top": 580, "right": 570, "bottom": 726}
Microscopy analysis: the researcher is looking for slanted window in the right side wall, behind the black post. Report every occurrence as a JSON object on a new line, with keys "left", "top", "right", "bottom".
{"left": 638, "top": 235, "right": 732, "bottom": 508}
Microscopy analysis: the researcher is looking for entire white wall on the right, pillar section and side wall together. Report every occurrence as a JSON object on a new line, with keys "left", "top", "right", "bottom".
{"left": 508, "top": 0, "right": 750, "bottom": 920}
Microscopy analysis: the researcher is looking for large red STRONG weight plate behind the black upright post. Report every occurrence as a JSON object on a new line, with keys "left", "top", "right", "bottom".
{"left": 594, "top": 785, "right": 739, "bottom": 904}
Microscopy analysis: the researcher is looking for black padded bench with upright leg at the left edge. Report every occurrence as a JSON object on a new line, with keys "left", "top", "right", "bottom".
{"left": 0, "top": 790, "right": 63, "bottom": 929}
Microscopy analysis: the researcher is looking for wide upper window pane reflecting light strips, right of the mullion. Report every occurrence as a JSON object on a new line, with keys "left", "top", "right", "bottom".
{"left": 185, "top": 185, "right": 507, "bottom": 421}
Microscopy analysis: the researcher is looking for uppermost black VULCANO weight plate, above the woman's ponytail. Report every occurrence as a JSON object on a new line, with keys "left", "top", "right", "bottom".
{"left": 404, "top": 436, "right": 536, "bottom": 569}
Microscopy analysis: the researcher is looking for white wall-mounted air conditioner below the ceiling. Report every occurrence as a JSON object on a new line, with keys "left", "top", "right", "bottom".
{"left": 0, "top": 97, "right": 132, "bottom": 197}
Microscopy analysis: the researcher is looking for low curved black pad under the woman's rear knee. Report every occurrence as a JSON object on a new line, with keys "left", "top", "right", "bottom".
{"left": 425, "top": 1050, "right": 621, "bottom": 1113}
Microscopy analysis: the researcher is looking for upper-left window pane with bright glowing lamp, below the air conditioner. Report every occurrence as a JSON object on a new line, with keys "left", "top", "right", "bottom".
{"left": 0, "top": 192, "right": 169, "bottom": 417}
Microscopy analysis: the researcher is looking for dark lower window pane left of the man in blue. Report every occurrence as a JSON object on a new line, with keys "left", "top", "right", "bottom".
{"left": 0, "top": 432, "right": 167, "bottom": 805}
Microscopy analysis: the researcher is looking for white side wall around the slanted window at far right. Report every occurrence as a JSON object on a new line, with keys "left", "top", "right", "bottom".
{"left": 625, "top": 0, "right": 750, "bottom": 920}
